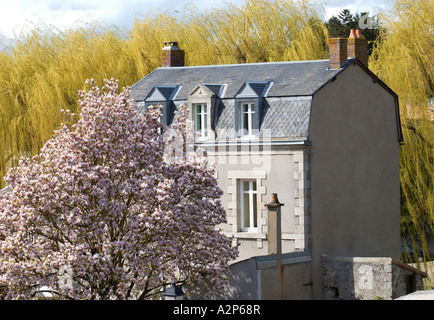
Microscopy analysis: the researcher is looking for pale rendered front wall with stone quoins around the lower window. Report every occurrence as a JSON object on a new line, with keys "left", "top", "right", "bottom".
{"left": 208, "top": 146, "right": 310, "bottom": 261}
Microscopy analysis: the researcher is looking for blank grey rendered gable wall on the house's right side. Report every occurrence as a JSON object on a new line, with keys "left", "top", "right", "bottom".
{"left": 309, "top": 65, "right": 400, "bottom": 299}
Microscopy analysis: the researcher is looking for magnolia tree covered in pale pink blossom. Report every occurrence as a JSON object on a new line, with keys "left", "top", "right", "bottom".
{"left": 0, "top": 80, "right": 237, "bottom": 299}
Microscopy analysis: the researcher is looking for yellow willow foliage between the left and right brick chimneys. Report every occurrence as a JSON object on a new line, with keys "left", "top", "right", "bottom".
{"left": 181, "top": 0, "right": 328, "bottom": 65}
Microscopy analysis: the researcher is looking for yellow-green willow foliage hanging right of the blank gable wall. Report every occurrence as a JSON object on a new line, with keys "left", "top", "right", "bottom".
{"left": 369, "top": 0, "right": 434, "bottom": 262}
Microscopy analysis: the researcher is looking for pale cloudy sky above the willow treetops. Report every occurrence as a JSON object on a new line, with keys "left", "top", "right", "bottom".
{"left": 0, "top": 0, "right": 390, "bottom": 38}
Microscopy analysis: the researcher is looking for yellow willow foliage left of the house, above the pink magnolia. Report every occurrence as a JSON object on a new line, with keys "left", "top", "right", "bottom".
{"left": 0, "top": 25, "right": 142, "bottom": 188}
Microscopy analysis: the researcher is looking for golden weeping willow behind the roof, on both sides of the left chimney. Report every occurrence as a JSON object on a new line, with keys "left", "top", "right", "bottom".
{"left": 131, "top": 0, "right": 328, "bottom": 65}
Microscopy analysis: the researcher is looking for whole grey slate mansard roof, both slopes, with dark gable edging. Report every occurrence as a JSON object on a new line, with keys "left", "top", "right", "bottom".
{"left": 131, "top": 58, "right": 403, "bottom": 142}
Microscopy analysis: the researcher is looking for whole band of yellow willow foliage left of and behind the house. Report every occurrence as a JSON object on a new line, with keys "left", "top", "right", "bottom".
{"left": 0, "top": 0, "right": 327, "bottom": 187}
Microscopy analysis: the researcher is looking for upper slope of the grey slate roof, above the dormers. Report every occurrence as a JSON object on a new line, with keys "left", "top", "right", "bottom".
{"left": 131, "top": 60, "right": 340, "bottom": 101}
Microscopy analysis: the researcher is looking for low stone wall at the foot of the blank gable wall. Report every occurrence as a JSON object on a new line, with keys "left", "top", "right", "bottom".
{"left": 322, "top": 256, "right": 426, "bottom": 300}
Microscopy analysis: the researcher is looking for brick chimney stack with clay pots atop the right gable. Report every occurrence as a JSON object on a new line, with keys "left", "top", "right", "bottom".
{"left": 329, "top": 29, "right": 368, "bottom": 69}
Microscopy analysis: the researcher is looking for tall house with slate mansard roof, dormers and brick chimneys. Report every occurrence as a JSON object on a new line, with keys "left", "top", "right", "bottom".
{"left": 131, "top": 31, "right": 403, "bottom": 299}
